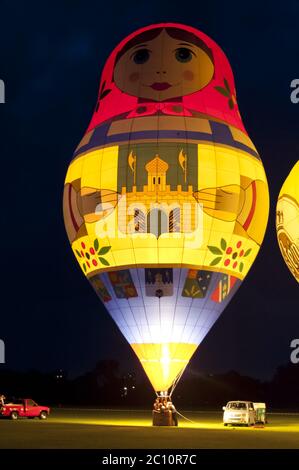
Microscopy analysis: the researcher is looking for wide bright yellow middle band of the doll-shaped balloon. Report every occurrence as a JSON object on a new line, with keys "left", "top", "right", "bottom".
{"left": 64, "top": 143, "right": 269, "bottom": 279}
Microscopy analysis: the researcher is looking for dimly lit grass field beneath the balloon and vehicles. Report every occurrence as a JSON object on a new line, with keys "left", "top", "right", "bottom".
{"left": 0, "top": 409, "right": 299, "bottom": 449}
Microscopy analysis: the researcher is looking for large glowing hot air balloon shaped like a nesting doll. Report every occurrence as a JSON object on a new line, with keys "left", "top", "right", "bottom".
{"left": 63, "top": 23, "right": 269, "bottom": 422}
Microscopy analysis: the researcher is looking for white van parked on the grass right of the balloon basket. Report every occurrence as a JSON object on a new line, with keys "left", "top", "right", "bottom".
{"left": 222, "top": 401, "right": 266, "bottom": 426}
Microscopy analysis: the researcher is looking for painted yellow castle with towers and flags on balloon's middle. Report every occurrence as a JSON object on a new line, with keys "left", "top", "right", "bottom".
{"left": 118, "top": 149, "right": 200, "bottom": 237}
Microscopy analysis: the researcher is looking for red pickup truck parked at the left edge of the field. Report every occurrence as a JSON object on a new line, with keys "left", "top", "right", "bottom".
{"left": 0, "top": 398, "right": 50, "bottom": 419}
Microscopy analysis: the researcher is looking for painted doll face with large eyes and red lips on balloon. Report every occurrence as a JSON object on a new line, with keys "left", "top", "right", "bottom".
{"left": 114, "top": 29, "right": 214, "bottom": 101}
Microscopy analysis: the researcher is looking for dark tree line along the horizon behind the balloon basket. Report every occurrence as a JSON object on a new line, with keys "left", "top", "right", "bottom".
{"left": 0, "top": 360, "right": 299, "bottom": 411}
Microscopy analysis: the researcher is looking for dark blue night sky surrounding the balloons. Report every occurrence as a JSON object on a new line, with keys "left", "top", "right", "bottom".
{"left": 0, "top": 0, "right": 299, "bottom": 379}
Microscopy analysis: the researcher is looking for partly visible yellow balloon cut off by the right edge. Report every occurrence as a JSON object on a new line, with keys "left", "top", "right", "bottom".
{"left": 276, "top": 161, "right": 299, "bottom": 282}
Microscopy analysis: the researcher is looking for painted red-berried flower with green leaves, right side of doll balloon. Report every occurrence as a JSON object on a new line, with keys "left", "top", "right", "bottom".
{"left": 208, "top": 238, "right": 252, "bottom": 273}
